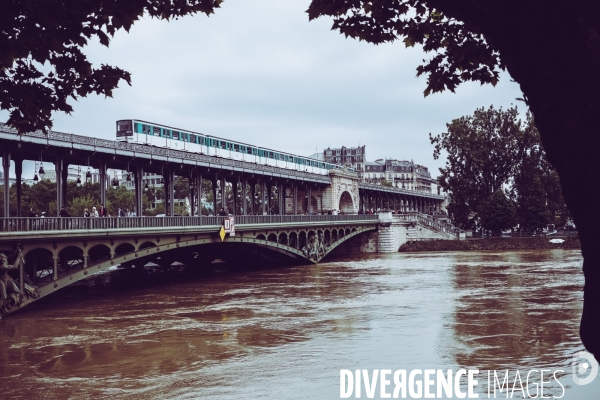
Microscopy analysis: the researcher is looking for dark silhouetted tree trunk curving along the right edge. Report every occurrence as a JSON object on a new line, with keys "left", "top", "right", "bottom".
{"left": 425, "top": 0, "right": 600, "bottom": 359}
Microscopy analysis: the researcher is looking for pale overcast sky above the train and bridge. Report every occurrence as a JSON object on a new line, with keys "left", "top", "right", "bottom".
{"left": 0, "top": 0, "right": 524, "bottom": 176}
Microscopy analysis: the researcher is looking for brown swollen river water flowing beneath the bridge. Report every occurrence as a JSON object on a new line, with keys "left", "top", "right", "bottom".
{"left": 0, "top": 250, "right": 600, "bottom": 400}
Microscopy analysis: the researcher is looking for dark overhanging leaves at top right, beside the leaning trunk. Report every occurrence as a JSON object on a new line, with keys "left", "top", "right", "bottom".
{"left": 307, "top": 0, "right": 505, "bottom": 96}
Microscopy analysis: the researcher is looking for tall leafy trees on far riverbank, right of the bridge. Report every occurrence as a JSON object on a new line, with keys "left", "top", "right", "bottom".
{"left": 430, "top": 106, "right": 570, "bottom": 232}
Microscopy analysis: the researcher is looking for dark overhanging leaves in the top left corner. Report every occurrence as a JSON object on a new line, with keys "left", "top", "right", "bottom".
{"left": 0, "top": 0, "right": 222, "bottom": 133}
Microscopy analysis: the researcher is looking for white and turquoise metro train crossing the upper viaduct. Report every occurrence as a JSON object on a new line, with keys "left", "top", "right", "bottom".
{"left": 117, "top": 119, "right": 354, "bottom": 175}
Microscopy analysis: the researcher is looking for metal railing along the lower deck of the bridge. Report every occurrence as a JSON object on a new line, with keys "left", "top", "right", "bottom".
{"left": 0, "top": 214, "right": 377, "bottom": 232}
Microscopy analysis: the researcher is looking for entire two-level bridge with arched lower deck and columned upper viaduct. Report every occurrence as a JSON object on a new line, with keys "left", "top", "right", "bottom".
{"left": 0, "top": 125, "right": 457, "bottom": 316}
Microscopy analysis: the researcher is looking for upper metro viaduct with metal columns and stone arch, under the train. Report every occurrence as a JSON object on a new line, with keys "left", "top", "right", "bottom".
{"left": 0, "top": 124, "right": 445, "bottom": 217}
